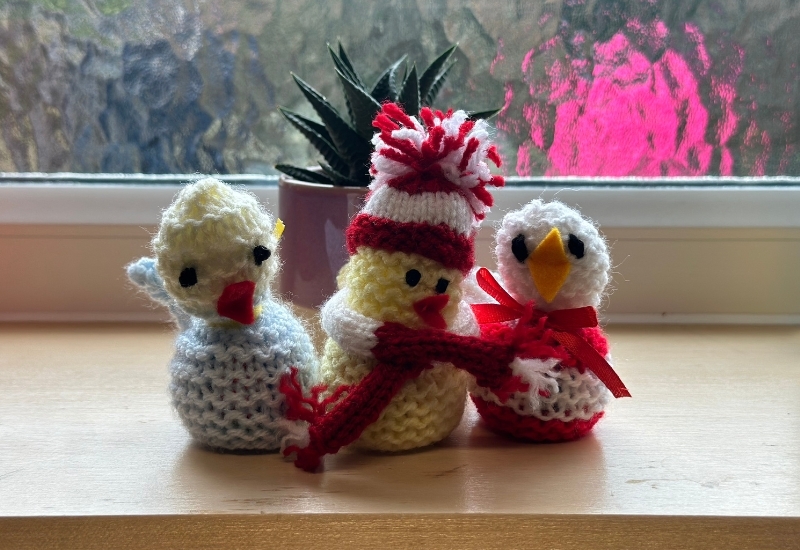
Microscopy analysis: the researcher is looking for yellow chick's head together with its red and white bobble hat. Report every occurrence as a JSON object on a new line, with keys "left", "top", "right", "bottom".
{"left": 340, "top": 103, "right": 504, "bottom": 328}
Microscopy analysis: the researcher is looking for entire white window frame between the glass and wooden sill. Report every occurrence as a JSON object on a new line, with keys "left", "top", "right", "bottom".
{"left": 0, "top": 174, "right": 800, "bottom": 323}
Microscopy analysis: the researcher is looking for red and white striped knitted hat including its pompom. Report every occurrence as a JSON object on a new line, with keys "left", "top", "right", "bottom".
{"left": 347, "top": 103, "right": 505, "bottom": 274}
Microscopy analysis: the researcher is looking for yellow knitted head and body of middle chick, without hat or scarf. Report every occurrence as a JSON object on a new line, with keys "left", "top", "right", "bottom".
{"left": 321, "top": 247, "right": 468, "bottom": 451}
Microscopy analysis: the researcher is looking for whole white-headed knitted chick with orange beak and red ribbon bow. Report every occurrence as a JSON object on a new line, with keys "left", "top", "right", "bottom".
{"left": 471, "top": 200, "right": 630, "bottom": 441}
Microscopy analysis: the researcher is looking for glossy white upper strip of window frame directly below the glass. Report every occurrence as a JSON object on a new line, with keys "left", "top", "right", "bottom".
{"left": 0, "top": 174, "right": 800, "bottom": 228}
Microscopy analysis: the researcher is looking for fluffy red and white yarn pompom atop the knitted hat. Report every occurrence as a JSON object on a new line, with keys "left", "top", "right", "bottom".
{"left": 370, "top": 103, "right": 504, "bottom": 226}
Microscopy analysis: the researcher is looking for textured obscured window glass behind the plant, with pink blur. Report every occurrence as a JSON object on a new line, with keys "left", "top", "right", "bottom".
{"left": 0, "top": 0, "right": 800, "bottom": 177}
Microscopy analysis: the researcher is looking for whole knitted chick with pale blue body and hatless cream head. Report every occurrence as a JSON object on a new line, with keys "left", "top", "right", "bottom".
{"left": 127, "top": 178, "right": 318, "bottom": 451}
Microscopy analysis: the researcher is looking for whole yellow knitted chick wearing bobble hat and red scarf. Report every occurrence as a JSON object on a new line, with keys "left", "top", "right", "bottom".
{"left": 280, "top": 104, "right": 511, "bottom": 471}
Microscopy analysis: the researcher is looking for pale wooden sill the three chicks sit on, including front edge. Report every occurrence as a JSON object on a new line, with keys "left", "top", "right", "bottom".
{"left": 0, "top": 324, "right": 800, "bottom": 548}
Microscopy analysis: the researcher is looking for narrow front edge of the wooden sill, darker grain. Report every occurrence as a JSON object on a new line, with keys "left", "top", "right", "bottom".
{"left": 0, "top": 514, "right": 800, "bottom": 550}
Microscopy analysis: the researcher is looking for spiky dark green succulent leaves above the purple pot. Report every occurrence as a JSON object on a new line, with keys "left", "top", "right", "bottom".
{"left": 275, "top": 43, "right": 499, "bottom": 187}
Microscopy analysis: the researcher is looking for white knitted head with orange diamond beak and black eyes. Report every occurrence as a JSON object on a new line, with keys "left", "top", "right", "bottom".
{"left": 495, "top": 200, "right": 611, "bottom": 311}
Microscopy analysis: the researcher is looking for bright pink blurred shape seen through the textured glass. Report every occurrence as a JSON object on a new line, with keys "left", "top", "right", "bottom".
{"left": 497, "top": 20, "right": 748, "bottom": 177}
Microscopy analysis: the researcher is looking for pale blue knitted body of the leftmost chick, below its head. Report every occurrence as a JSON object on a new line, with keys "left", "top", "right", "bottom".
{"left": 169, "top": 300, "right": 315, "bottom": 451}
